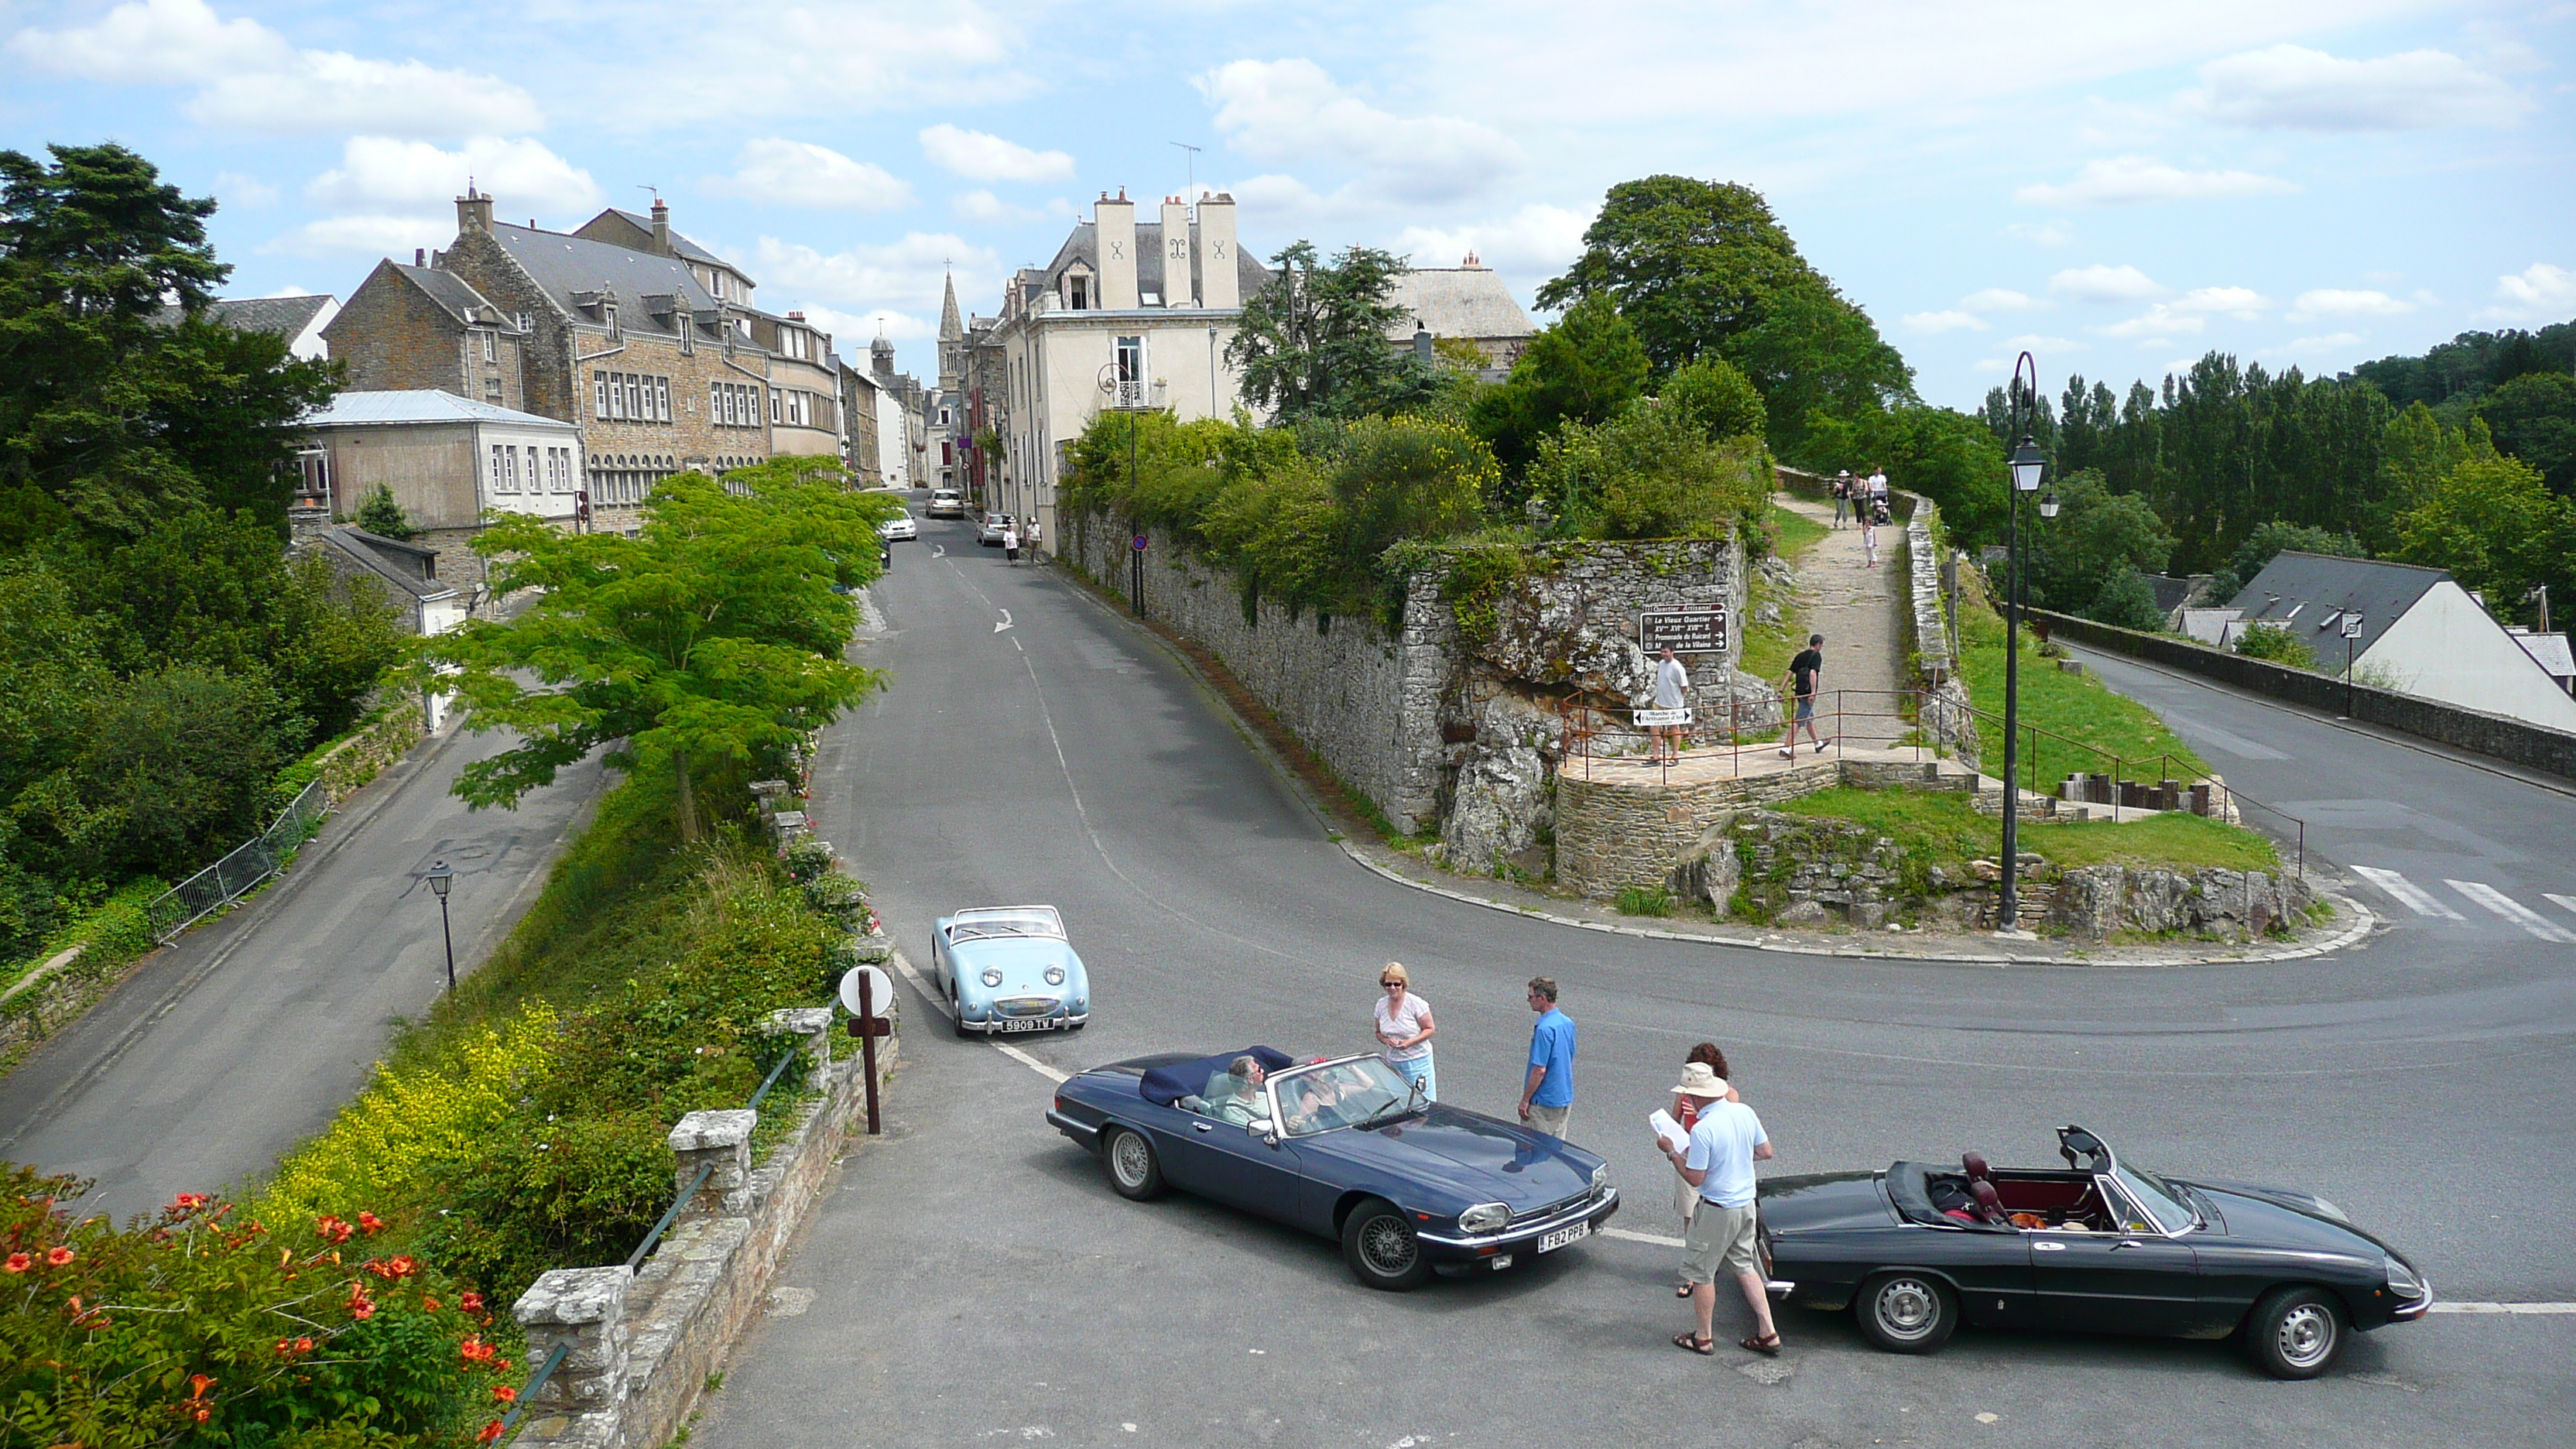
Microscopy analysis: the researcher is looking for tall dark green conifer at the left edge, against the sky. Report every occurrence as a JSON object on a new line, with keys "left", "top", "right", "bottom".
{"left": 0, "top": 145, "right": 337, "bottom": 536}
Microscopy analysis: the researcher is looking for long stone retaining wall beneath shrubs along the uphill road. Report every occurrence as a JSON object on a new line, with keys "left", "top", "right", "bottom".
{"left": 1056, "top": 511, "right": 1455, "bottom": 833}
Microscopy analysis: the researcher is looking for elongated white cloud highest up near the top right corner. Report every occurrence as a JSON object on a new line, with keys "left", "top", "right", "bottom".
{"left": 2182, "top": 44, "right": 2535, "bottom": 132}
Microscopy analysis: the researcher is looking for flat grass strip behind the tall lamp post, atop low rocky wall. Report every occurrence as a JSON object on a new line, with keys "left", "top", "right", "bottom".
{"left": 1780, "top": 786, "right": 2280, "bottom": 879}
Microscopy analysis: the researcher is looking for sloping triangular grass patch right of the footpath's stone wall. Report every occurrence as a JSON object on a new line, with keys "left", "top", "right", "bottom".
{"left": 1958, "top": 570, "right": 2210, "bottom": 794}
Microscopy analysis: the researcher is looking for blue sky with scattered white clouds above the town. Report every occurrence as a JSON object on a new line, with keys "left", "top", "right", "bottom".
{"left": 0, "top": 0, "right": 2576, "bottom": 407}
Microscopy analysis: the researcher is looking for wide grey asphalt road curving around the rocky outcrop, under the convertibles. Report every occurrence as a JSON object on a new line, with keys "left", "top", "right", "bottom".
{"left": 698, "top": 502, "right": 2576, "bottom": 1447}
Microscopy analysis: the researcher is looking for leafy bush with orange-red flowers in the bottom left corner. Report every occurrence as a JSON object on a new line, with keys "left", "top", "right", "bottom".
{"left": 0, "top": 1166, "right": 518, "bottom": 1449}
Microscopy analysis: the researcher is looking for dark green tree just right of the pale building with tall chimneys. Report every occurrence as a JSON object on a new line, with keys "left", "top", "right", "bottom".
{"left": 1226, "top": 242, "right": 1435, "bottom": 423}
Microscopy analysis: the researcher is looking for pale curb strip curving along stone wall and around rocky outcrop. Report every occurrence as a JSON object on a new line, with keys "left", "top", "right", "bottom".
{"left": 1025, "top": 551, "right": 2380, "bottom": 969}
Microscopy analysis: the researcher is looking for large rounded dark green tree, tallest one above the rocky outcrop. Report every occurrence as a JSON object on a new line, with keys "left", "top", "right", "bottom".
{"left": 1538, "top": 176, "right": 1814, "bottom": 374}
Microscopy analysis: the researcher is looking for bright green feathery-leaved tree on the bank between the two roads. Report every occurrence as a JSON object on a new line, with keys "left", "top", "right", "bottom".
{"left": 417, "top": 459, "right": 891, "bottom": 838}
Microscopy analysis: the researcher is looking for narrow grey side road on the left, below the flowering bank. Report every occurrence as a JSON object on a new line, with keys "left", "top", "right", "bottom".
{"left": 0, "top": 711, "right": 603, "bottom": 1220}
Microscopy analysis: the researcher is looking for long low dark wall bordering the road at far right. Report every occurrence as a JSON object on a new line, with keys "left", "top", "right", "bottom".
{"left": 2033, "top": 608, "right": 2576, "bottom": 779}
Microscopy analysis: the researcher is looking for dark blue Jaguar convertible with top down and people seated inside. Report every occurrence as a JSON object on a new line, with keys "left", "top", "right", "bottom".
{"left": 1046, "top": 1046, "right": 1618, "bottom": 1289}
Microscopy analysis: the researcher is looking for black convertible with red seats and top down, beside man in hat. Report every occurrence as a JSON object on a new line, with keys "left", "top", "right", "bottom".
{"left": 1759, "top": 1127, "right": 2432, "bottom": 1379}
